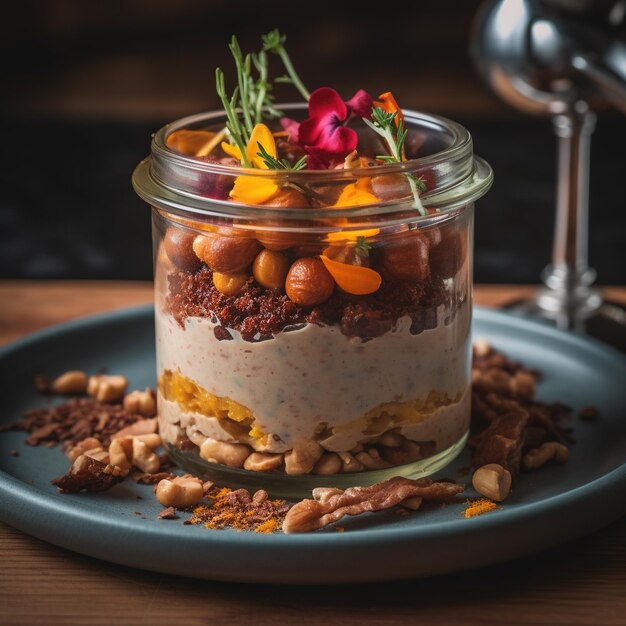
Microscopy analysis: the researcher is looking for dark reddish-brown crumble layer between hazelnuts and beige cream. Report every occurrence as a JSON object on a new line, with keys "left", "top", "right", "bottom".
{"left": 165, "top": 266, "right": 456, "bottom": 341}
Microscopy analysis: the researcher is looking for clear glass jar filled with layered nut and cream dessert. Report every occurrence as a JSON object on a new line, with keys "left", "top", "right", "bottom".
{"left": 133, "top": 105, "right": 492, "bottom": 497}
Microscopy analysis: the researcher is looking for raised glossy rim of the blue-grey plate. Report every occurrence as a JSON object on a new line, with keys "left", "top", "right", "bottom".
{"left": 0, "top": 304, "right": 626, "bottom": 582}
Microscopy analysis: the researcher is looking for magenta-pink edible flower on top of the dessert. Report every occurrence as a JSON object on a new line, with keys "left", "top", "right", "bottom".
{"left": 298, "top": 87, "right": 372, "bottom": 169}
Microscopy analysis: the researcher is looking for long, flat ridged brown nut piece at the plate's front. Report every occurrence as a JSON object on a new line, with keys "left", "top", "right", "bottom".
{"left": 283, "top": 476, "right": 464, "bottom": 533}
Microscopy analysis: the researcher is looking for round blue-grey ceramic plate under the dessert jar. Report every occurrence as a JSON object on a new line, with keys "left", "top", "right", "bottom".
{"left": 0, "top": 307, "right": 626, "bottom": 583}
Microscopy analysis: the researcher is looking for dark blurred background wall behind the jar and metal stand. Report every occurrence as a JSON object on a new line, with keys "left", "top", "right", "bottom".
{"left": 0, "top": 0, "right": 626, "bottom": 284}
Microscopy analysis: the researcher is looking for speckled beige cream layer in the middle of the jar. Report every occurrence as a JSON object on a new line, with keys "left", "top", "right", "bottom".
{"left": 156, "top": 303, "right": 470, "bottom": 452}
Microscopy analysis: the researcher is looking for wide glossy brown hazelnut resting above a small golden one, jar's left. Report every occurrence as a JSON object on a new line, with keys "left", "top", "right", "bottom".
{"left": 193, "top": 234, "right": 261, "bottom": 274}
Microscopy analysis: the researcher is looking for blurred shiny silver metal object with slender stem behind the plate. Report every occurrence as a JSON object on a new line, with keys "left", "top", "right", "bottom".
{"left": 471, "top": 0, "right": 626, "bottom": 342}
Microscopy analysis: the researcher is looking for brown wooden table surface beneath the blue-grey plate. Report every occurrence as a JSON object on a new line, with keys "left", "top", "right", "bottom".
{"left": 0, "top": 281, "right": 626, "bottom": 626}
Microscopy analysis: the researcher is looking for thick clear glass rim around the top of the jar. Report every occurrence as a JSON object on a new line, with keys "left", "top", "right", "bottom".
{"left": 133, "top": 103, "right": 493, "bottom": 222}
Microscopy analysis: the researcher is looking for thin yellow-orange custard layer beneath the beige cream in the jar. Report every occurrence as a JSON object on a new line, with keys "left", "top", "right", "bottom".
{"left": 159, "top": 370, "right": 462, "bottom": 449}
